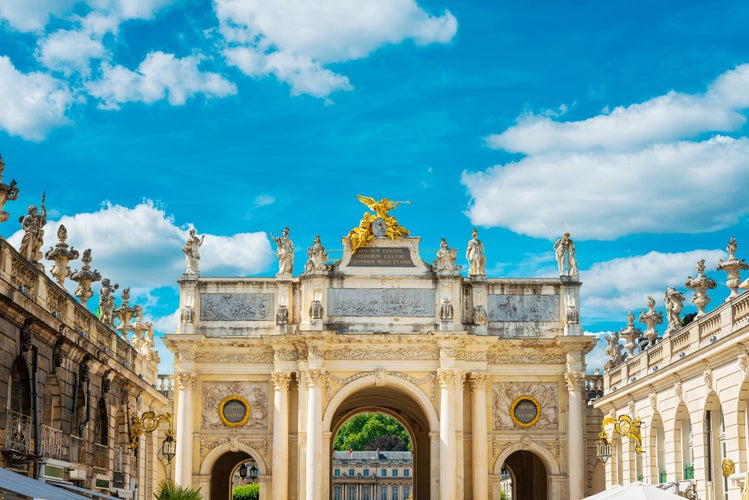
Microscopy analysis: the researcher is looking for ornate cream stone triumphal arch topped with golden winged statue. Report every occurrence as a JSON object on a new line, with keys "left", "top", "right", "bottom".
{"left": 166, "top": 197, "right": 595, "bottom": 500}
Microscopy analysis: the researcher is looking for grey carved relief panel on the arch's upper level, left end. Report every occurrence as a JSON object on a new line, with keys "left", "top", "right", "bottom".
{"left": 200, "top": 293, "right": 275, "bottom": 321}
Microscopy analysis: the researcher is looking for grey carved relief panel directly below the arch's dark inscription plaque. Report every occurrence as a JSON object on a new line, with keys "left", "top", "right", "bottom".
{"left": 328, "top": 288, "right": 435, "bottom": 318}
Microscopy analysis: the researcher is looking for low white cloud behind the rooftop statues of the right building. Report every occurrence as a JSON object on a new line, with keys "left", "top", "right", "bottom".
{"left": 580, "top": 250, "right": 728, "bottom": 326}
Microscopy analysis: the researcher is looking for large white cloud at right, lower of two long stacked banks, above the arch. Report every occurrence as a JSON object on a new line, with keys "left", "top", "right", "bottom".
{"left": 462, "top": 136, "right": 749, "bottom": 239}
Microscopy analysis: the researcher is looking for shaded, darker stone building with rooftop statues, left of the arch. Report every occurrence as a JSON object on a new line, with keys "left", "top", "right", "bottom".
{"left": 0, "top": 158, "right": 170, "bottom": 498}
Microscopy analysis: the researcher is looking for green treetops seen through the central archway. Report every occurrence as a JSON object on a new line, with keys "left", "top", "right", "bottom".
{"left": 333, "top": 413, "right": 413, "bottom": 451}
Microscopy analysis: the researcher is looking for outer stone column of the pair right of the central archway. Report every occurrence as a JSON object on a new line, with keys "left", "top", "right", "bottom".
{"left": 470, "top": 372, "right": 489, "bottom": 500}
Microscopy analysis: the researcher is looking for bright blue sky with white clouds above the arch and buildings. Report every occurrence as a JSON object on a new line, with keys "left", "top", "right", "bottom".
{"left": 0, "top": 0, "right": 749, "bottom": 371}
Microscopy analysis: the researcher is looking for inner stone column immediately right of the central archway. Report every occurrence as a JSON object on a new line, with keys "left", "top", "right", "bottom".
{"left": 437, "top": 369, "right": 458, "bottom": 498}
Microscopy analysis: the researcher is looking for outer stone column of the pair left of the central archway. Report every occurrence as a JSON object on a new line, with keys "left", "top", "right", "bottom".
{"left": 272, "top": 371, "right": 291, "bottom": 500}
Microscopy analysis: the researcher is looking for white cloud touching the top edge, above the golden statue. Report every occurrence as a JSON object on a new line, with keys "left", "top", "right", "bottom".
{"left": 215, "top": 0, "right": 457, "bottom": 97}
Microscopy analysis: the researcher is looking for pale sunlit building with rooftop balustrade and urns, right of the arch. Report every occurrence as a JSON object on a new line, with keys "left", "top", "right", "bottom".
{"left": 595, "top": 239, "right": 749, "bottom": 500}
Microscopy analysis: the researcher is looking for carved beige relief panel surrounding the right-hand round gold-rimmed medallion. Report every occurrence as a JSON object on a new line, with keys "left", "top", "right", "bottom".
{"left": 492, "top": 382, "right": 559, "bottom": 430}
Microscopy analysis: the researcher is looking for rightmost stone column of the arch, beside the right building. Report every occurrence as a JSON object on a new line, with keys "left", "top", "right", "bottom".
{"left": 564, "top": 371, "right": 585, "bottom": 500}
